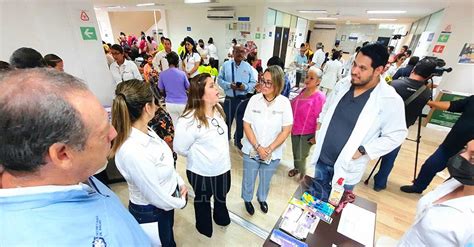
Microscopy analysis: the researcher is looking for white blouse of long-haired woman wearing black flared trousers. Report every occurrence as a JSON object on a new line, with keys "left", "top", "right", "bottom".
{"left": 173, "top": 112, "right": 230, "bottom": 177}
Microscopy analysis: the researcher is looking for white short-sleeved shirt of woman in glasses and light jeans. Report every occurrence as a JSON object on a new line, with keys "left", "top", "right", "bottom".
{"left": 242, "top": 93, "right": 293, "bottom": 160}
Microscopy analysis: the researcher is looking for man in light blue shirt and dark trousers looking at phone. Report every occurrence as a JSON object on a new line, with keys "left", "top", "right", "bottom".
{"left": 217, "top": 44, "right": 256, "bottom": 149}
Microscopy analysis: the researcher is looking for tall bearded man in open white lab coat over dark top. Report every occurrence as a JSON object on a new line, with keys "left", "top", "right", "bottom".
{"left": 311, "top": 44, "right": 407, "bottom": 199}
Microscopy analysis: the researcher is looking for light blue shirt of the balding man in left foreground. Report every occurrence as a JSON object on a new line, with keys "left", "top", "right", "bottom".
{"left": 0, "top": 177, "right": 151, "bottom": 247}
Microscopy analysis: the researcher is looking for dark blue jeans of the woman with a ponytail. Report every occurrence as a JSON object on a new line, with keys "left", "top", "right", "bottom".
{"left": 128, "top": 202, "right": 176, "bottom": 247}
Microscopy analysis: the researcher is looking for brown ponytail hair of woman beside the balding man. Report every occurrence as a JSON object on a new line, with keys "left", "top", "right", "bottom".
{"left": 109, "top": 79, "right": 154, "bottom": 157}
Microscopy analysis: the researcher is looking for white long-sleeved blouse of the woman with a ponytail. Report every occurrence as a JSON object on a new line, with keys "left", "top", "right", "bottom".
{"left": 115, "top": 127, "right": 186, "bottom": 211}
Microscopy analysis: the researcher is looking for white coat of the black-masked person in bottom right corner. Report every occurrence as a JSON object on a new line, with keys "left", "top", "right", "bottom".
{"left": 398, "top": 179, "right": 474, "bottom": 247}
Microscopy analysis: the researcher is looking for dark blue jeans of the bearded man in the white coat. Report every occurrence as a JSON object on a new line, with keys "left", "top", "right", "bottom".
{"left": 309, "top": 161, "right": 355, "bottom": 201}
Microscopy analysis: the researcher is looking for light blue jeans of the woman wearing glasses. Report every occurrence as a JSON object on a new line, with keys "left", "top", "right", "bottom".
{"left": 242, "top": 154, "right": 280, "bottom": 202}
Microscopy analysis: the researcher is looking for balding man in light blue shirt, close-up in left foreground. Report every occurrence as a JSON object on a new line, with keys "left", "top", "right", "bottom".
{"left": 0, "top": 69, "right": 151, "bottom": 246}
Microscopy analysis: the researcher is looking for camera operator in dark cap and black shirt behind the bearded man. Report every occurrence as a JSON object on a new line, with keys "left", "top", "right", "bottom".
{"left": 374, "top": 58, "right": 437, "bottom": 191}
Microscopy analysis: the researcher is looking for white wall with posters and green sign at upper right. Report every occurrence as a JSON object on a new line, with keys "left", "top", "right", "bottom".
{"left": 430, "top": 2, "right": 474, "bottom": 94}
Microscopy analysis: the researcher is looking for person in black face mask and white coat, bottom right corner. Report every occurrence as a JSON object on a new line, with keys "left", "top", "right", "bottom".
{"left": 398, "top": 139, "right": 474, "bottom": 246}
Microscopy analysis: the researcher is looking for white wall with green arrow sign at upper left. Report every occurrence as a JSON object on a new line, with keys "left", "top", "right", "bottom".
{"left": 0, "top": 0, "right": 115, "bottom": 104}
